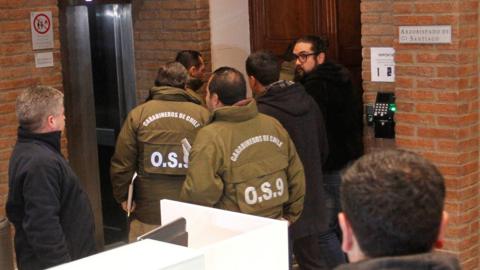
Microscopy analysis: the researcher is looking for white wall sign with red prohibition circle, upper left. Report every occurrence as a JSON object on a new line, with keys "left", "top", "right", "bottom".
{"left": 30, "top": 11, "right": 53, "bottom": 50}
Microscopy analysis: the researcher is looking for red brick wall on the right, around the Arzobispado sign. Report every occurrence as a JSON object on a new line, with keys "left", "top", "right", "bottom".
{"left": 361, "top": 0, "right": 480, "bottom": 269}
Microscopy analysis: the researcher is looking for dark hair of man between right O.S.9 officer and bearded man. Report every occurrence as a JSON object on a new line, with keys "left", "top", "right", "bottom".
{"left": 245, "top": 51, "right": 280, "bottom": 86}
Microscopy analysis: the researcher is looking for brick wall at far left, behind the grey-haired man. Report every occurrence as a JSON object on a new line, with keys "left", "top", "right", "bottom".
{"left": 0, "top": 0, "right": 62, "bottom": 217}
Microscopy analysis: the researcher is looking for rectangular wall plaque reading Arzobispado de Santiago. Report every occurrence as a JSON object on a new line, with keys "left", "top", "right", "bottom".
{"left": 398, "top": 25, "right": 452, "bottom": 44}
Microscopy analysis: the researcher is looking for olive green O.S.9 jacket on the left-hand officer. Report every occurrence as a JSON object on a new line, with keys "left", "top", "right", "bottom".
{"left": 110, "top": 87, "right": 210, "bottom": 224}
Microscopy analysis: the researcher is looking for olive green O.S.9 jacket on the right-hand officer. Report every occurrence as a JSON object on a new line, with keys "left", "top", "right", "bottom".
{"left": 180, "top": 101, "right": 305, "bottom": 223}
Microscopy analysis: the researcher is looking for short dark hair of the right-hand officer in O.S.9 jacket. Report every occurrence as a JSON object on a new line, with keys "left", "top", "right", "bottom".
{"left": 208, "top": 67, "right": 247, "bottom": 105}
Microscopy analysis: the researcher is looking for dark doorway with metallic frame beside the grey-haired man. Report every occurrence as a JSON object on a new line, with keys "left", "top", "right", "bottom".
{"left": 60, "top": 1, "right": 136, "bottom": 249}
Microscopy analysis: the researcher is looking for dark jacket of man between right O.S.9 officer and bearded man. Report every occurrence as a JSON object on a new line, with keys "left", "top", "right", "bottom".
{"left": 257, "top": 83, "right": 328, "bottom": 239}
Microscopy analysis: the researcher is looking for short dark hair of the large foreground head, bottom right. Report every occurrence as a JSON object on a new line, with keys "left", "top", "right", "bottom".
{"left": 340, "top": 150, "right": 445, "bottom": 258}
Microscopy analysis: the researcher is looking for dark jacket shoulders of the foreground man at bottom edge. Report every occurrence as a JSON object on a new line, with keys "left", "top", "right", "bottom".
{"left": 335, "top": 252, "right": 461, "bottom": 270}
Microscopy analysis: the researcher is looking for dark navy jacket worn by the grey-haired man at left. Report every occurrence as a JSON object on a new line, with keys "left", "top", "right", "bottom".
{"left": 6, "top": 128, "right": 95, "bottom": 269}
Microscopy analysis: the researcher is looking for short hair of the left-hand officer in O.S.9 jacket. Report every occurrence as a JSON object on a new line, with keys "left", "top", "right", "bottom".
{"left": 155, "top": 62, "right": 188, "bottom": 89}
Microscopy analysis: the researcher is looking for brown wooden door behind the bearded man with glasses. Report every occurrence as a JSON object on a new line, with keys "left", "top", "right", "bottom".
{"left": 249, "top": 0, "right": 362, "bottom": 89}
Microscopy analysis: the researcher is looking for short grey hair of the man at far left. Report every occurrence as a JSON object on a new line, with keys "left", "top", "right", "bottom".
{"left": 16, "top": 86, "right": 63, "bottom": 132}
